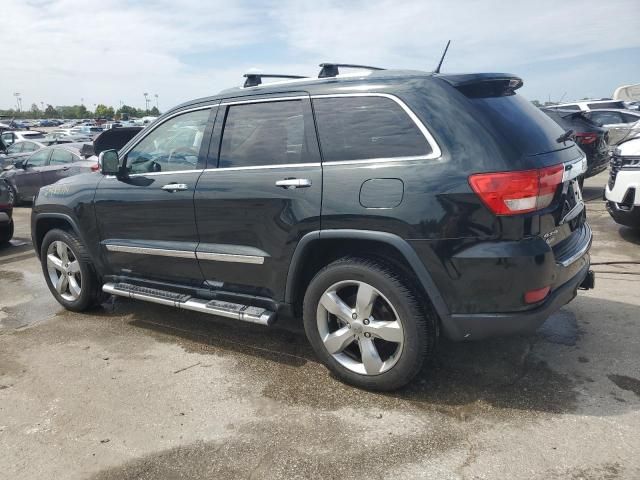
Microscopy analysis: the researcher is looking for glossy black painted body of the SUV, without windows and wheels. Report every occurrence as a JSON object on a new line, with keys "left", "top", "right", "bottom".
{"left": 32, "top": 71, "right": 590, "bottom": 340}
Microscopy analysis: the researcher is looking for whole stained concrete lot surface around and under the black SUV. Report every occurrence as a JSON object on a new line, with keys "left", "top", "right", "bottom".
{"left": 0, "top": 174, "right": 640, "bottom": 480}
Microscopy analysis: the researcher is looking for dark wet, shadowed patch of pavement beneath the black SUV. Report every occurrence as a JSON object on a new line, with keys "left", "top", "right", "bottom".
{"left": 107, "top": 301, "right": 577, "bottom": 421}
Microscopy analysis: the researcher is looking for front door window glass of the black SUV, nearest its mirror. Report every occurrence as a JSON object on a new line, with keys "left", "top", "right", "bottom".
{"left": 127, "top": 108, "right": 211, "bottom": 173}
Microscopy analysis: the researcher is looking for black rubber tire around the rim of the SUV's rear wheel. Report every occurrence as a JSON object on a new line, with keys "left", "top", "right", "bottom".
{"left": 303, "top": 261, "right": 428, "bottom": 390}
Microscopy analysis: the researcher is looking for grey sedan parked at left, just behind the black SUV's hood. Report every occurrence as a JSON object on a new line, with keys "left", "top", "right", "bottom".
{"left": 0, "top": 143, "right": 99, "bottom": 205}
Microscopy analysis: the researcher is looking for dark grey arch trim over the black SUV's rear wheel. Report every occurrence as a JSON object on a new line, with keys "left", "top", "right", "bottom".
{"left": 284, "top": 229, "right": 450, "bottom": 322}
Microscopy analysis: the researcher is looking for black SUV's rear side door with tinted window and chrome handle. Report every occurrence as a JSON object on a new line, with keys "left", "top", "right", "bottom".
{"left": 190, "top": 94, "right": 322, "bottom": 299}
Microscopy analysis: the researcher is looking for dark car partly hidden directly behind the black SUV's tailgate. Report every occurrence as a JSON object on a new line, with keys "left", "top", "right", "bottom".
{"left": 542, "top": 108, "right": 609, "bottom": 178}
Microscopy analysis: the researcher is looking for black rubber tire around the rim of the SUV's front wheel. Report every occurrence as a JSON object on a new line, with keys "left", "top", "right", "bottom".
{"left": 40, "top": 230, "right": 95, "bottom": 312}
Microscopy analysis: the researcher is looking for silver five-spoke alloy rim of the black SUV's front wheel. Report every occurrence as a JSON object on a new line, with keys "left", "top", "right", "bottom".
{"left": 47, "top": 240, "right": 82, "bottom": 302}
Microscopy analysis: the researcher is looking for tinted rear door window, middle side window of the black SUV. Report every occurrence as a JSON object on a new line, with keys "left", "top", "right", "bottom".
{"left": 219, "top": 100, "right": 308, "bottom": 168}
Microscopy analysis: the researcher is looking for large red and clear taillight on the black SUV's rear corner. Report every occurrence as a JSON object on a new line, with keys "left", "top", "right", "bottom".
{"left": 469, "top": 165, "right": 564, "bottom": 215}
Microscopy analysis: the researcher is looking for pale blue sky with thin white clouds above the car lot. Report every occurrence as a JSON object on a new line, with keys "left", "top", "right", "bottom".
{"left": 0, "top": 0, "right": 640, "bottom": 110}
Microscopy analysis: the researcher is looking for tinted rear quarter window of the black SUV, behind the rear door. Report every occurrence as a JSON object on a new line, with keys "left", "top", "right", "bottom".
{"left": 313, "top": 97, "right": 432, "bottom": 162}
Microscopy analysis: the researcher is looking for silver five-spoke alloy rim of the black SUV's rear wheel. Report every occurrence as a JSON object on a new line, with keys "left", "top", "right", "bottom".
{"left": 316, "top": 280, "right": 404, "bottom": 375}
